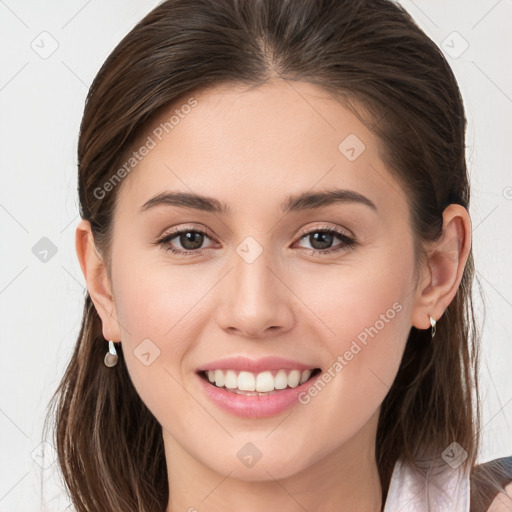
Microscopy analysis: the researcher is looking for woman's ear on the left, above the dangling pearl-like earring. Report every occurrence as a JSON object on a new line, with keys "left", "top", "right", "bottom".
{"left": 75, "top": 219, "right": 121, "bottom": 341}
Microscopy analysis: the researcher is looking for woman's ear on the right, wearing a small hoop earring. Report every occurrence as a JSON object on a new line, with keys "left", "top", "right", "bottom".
{"left": 411, "top": 204, "right": 471, "bottom": 329}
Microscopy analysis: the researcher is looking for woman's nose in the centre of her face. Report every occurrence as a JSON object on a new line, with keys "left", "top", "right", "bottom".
{"left": 216, "top": 247, "right": 295, "bottom": 339}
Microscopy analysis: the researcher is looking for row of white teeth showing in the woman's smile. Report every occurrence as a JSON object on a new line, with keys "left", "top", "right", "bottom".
{"left": 206, "top": 370, "right": 313, "bottom": 394}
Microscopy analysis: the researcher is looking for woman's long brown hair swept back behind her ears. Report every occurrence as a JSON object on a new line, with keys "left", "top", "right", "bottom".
{"left": 44, "top": 0, "right": 500, "bottom": 512}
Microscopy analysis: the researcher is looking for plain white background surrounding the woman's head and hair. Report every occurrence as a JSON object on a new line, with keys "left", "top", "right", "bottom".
{"left": 0, "top": 0, "right": 512, "bottom": 512}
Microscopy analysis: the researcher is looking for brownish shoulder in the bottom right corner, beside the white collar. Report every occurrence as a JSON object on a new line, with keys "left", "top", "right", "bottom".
{"left": 470, "top": 456, "right": 512, "bottom": 512}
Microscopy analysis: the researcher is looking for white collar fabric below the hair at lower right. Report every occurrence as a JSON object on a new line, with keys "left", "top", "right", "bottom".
{"left": 384, "top": 459, "right": 470, "bottom": 512}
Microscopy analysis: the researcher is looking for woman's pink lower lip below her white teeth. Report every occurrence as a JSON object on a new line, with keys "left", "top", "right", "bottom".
{"left": 196, "top": 372, "right": 321, "bottom": 418}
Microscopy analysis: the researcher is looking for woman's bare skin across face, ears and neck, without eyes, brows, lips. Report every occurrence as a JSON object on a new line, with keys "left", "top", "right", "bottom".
{"left": 76, "top": 80, "right": 471, "bottom": 512}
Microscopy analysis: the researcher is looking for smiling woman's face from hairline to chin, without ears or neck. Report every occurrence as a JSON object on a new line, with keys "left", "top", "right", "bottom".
{"left": 102, "top": 81, "right": 415, "bottom": 480}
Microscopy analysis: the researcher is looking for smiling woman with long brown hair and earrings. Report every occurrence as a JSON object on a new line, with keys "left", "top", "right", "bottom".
{"left": 45, "top": 0, "right": 512, "bottom": 512}
